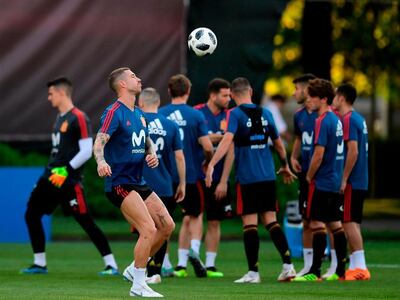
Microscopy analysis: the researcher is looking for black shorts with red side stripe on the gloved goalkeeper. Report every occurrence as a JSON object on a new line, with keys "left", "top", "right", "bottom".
{"left": 28, "top": 177, "right": 88, "bottom": 215}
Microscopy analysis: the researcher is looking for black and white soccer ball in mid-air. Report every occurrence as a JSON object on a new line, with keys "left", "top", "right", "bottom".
{"left": 188, "top": 27, "right": 217, "bottom": 56}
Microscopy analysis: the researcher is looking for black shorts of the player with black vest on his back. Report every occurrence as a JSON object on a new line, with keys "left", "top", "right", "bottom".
{"left": 236, "top": 180, "right": 277, "bottom": 215}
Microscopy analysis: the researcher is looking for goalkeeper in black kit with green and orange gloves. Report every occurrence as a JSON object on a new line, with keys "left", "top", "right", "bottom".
{"left": 21, "top": 77, "right": 119, "bottom": 275}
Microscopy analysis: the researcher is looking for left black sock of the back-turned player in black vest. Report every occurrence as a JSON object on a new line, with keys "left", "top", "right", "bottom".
{"left": 243, "top": 225, "right": 260, "bottom": 272}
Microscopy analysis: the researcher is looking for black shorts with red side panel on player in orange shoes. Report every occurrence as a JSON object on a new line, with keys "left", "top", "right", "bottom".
{"left": 342, "top": 184, "right": 367, "bottom": 224}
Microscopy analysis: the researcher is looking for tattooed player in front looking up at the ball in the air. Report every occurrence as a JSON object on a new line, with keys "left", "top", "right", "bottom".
{"left": 94, "top": 67, "right": 175, "bottom": 297}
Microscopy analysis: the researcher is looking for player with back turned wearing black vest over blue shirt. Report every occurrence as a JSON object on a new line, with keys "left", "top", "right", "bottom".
{"left": 206, "top": 77, "right": 296, "bottom": 283}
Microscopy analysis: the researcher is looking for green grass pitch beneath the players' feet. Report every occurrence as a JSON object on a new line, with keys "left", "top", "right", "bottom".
{"left": 0, "top": 238, "right": 400, "bottom": 299}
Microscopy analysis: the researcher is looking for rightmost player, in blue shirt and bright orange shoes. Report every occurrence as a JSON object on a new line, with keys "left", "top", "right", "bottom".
{"left": 333, "top": 83, "right": 371, "bottom": 280}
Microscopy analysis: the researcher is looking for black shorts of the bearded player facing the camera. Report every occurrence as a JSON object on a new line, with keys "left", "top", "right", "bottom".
{"left": 202, "top": 181, "right": 231, "bottom": 221}
